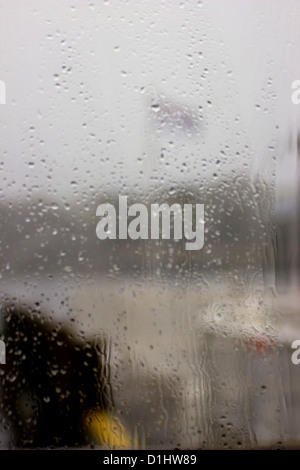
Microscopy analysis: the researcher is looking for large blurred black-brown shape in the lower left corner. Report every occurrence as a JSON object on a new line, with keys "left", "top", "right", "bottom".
{"left": 0, "top": 305, "right": 113, "bottom": 448}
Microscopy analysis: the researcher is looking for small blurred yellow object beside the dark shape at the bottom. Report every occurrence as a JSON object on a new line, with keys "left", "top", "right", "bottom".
{"left": 84, "top": 409, "right": 138, "bottom": 449}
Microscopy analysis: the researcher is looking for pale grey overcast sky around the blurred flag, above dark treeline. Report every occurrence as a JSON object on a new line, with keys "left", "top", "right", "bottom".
{"left": 0, "top": 0, "right": 300, "bottom": 197}
